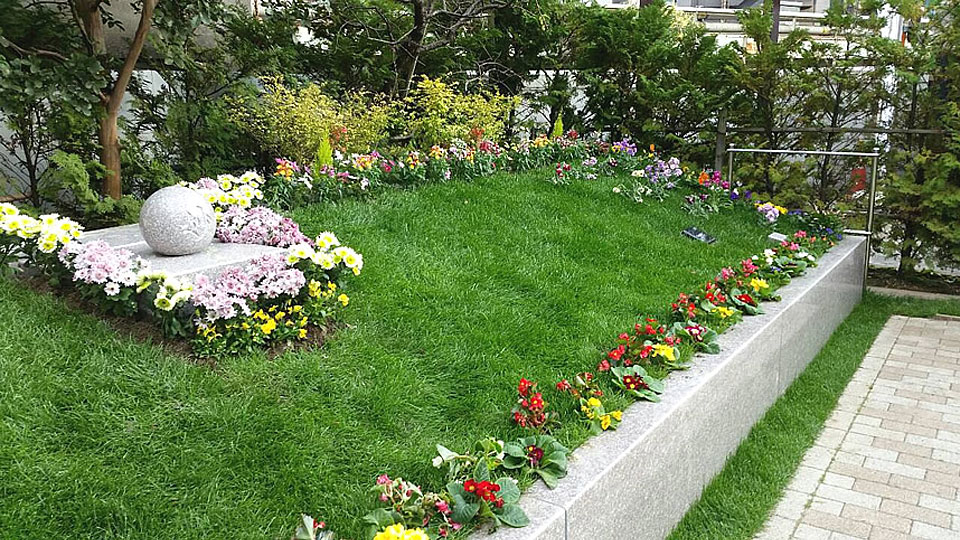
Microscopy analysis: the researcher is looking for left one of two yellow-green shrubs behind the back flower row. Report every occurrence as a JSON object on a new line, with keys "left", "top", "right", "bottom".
{"left": 228, "top": 77, "right": 391, "bottom": 163}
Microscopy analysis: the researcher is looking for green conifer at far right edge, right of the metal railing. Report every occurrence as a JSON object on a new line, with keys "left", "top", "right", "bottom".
{"left": 881, "top": 1, "right": 960, "bottom": 274}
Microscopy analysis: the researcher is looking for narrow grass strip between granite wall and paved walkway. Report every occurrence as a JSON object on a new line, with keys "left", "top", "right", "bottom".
{"left": 669, "top": 293, "right": 960, "bottom": 540}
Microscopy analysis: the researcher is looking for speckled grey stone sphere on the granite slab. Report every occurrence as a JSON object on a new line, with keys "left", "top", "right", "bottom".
{"left": 140, "top": 186, "right": 217, "bottom": 255}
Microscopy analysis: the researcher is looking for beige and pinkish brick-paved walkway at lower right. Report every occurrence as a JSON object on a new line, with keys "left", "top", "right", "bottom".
{"left": 757, "top": 316, "right": 960, "bottom": 540}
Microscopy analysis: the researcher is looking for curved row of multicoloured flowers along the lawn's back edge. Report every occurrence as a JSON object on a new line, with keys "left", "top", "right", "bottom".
{"left": 204, "top": 131, "right": 735, "bottom": 212}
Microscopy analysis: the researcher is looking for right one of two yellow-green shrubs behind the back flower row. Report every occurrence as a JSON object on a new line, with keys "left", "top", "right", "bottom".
{"left": 406, "top": 76, "right": 519, "bottom": 147}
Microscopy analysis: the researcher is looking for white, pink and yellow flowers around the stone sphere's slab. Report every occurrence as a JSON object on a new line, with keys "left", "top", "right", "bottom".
{"left": 0, "top": 197, "right": 363, "bottom": 356}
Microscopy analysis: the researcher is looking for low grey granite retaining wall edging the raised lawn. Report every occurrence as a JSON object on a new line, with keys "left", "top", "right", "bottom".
{"left": 488, "top": 237, "right": 866, "bottom": 540}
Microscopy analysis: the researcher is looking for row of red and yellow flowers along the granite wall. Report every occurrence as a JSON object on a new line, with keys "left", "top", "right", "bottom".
{"left": 295, "top": 207, "right": 839, "bottom": 540}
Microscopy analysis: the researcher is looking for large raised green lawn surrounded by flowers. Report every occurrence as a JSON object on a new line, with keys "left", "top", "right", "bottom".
{"left": 0, "top": 171, "right": 766, "bottom": 540}
